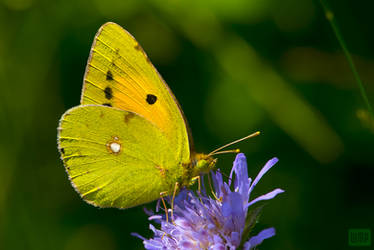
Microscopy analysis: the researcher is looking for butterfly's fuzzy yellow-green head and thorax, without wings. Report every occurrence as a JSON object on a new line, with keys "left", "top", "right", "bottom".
{"left": 180, "top": 154, "right": 217, "bottom": 187}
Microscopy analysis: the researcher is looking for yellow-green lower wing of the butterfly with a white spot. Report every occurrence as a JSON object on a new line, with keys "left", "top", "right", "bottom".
{"left": 58, "top": 105, "right": 181, "bottom": 208}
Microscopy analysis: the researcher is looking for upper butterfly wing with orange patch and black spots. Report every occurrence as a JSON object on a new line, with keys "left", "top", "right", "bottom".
{"left": 81, "top": 23, "right": 192, "bottom": 163}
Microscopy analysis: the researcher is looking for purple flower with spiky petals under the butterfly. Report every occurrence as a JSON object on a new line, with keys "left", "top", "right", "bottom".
{"left": 134, "top": 154, "right": 284, "bottom": 250}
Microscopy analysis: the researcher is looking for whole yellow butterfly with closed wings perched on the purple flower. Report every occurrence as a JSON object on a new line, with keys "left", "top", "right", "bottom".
{"left": 58, "top": 22, "right": 258, "bottom": 208}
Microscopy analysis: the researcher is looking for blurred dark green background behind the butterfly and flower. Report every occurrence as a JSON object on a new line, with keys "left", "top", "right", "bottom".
{"left": 0, "top": 0, "right": 374, "bottom": 250}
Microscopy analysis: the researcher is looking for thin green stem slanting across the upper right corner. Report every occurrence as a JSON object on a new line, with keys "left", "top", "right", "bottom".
{"left": 320, "top": 0, "right": 374, "bottom": 119}
